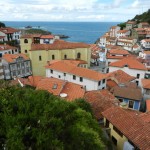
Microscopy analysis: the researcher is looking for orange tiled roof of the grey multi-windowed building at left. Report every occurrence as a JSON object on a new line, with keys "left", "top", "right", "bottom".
{"left": 2, "top": 54, "right": 29, "bottom": 63}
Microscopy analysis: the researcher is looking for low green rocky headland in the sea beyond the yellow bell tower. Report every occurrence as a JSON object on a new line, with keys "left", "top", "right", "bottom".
{"left": 24, "top": 29, "right": 51, "bottom": 34}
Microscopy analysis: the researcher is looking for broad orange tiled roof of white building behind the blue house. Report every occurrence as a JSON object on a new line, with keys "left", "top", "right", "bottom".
{"left": 109, "top": 57, "right": 147, "bottom": 70}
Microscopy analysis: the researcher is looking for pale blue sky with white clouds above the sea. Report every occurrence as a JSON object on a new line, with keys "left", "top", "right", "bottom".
{"left": 0, "top": 0, "right": 150, "bottom": 22}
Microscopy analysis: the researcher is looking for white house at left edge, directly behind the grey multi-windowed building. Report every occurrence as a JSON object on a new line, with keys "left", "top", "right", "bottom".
{"left": 0, "top": 44, "right": 19, "bottom": 57}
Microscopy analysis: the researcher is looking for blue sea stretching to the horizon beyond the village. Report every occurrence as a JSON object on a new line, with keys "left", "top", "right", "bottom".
{"left": 4, "top": 21, "right": 118, "bottom": 44}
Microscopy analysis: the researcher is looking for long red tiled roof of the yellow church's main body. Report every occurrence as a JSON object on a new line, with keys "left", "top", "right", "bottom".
{"left": 31, "top": 40, "right": 90, "bottom": 51}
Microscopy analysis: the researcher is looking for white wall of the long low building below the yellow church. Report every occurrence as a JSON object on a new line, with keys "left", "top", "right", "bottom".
{"left": 46, "top": 69, "right": 106, "bottom": 91}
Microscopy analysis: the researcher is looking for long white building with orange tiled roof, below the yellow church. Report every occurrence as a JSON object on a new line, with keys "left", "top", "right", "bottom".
{"left": 46, "top": 60, "right": 106, "bottom": 91}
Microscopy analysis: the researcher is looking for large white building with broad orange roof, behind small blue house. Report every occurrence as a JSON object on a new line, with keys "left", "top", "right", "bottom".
{"left": 109, "top": 57, "right": 147, "bottom": 86}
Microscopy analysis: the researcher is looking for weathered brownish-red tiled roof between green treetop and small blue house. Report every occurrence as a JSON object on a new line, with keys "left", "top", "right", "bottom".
{"left": 84, "top": 90, "right": 119, "bottom": 119}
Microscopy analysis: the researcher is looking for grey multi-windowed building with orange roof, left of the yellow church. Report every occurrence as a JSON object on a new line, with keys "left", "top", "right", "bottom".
{"left": 2, "top": 54, "right": 32, "bottom": 80}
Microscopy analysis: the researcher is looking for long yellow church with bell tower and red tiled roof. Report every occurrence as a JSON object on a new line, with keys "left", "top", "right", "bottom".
{"left": 20, "top": 35, "right": 91, "bottom": 76}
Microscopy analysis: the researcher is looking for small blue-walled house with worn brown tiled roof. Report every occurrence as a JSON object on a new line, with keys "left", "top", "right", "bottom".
{"left": 110, "top": 83, "right": 143, "bottom": 111}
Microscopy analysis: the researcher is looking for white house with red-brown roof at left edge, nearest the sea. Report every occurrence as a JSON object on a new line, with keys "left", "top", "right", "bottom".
{"left": 0, "top": 27, "right": 21, "bottom": 42}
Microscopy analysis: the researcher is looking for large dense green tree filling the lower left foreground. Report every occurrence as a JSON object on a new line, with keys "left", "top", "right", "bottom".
{"left": 0, "top": 84, "right": 105, "bottom": 150}
